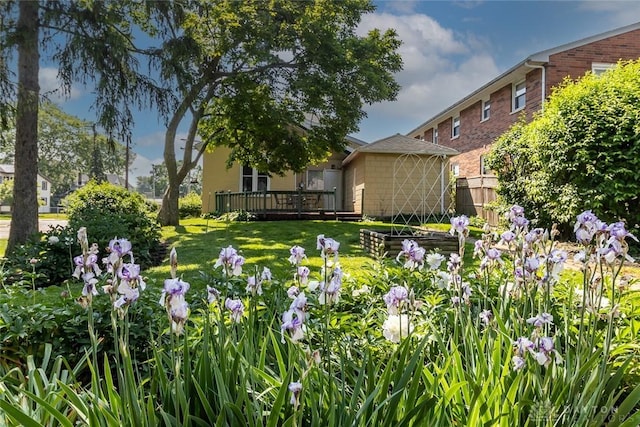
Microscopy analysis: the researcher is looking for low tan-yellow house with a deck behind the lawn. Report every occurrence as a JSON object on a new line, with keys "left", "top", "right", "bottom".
{"left": 202, "top": 134, "right": 458, "bottom": 218}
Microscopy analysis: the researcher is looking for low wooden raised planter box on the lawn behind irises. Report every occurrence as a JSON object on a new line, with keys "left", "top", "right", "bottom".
{"left": 360, "top": 229, "right": 459, "bottom": 258}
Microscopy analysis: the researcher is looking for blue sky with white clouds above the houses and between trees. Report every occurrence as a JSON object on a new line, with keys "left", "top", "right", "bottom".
{"left": 40, "top": 0, "right": 640, "bottom": 184}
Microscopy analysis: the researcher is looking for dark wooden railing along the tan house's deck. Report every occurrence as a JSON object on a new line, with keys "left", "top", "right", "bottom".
{"left": 215, "top": 188, "right": 336, "bottom": 215}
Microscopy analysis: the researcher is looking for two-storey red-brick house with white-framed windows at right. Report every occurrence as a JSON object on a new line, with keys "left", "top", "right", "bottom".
{"left": 407, "top": 23, "right": 640, "bottom": 221}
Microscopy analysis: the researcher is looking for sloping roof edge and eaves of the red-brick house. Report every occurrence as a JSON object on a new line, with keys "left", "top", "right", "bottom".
{"left": 407, "top": 22, "right": 640, "bottom": 135}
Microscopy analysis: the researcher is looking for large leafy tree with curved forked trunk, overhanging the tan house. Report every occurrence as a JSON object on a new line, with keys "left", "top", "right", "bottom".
{"left": 150, "top": 0, "right": 402, "bottom": 225}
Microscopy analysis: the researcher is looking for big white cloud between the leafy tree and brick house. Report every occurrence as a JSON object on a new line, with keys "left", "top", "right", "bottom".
{"left": 359, "top": 13, "right": 500, "bottom": 135}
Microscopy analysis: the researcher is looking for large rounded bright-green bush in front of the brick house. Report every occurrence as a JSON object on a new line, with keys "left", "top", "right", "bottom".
{"left": 487, "top": 61, "right": 640, "bottom": 234}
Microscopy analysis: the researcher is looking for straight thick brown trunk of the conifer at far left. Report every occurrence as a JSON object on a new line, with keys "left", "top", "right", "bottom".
{"left": 6, "top": 1, "right": 40, "bottom": 253}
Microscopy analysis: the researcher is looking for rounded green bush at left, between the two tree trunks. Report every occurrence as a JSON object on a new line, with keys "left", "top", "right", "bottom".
{"left": 64, "top": 182, "right": 162, "bottom": 269}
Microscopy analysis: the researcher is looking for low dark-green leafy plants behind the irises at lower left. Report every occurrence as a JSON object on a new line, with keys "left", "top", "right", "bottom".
{"left": 0, "top": 286, "right": 159, "bottom": 376}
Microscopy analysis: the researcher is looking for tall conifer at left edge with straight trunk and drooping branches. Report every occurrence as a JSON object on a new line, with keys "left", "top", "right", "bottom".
{"left": 0, "top": 0, "right": 166, "bottom": 252}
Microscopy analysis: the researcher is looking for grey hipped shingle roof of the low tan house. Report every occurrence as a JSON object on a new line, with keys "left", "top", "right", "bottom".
{"left": 342, "top": 133, "right": 459, "bottom": 165}
